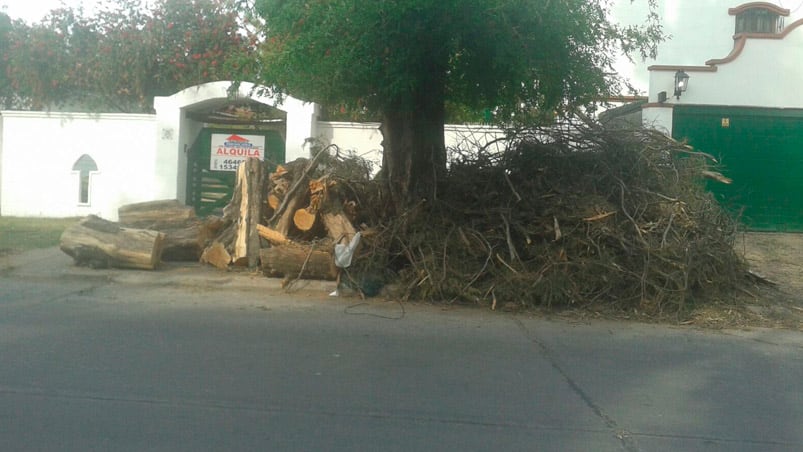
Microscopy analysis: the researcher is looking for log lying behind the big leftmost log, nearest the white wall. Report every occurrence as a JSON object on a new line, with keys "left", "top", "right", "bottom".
{"left": 117, "top": 199, "right": 196, "bottom": 231}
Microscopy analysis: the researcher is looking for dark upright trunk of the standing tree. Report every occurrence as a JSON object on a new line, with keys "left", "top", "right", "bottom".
{"left": 381, "top": 82, "right": 446, "bottom": 213}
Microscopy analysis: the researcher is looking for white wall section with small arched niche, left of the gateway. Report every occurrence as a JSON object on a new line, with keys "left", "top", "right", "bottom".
{"left": 0, "top": 111, "right": 156, "bottom": 220}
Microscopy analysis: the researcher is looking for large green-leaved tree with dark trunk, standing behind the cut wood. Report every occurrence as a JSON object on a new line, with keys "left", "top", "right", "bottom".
{"left": 256, "top": 0, "right": 662, "bottom": 212}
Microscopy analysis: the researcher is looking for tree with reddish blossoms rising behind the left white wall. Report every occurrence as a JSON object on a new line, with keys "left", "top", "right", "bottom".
{"left": 0, "top": 0, "right": 257, "bottom": 112}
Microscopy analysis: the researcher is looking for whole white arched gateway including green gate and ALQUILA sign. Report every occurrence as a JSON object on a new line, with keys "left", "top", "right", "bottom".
{"left": 154, "top": 82, "right": 318, "bottom": 214}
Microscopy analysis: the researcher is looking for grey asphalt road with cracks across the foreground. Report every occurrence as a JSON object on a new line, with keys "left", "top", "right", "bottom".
{"left": 0, "top": 250, "right": 803, "bottom": 451}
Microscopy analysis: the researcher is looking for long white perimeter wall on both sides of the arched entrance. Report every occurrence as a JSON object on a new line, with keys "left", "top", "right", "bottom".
{"left": 0, "top": 111, "right": 504, "bottom": 221}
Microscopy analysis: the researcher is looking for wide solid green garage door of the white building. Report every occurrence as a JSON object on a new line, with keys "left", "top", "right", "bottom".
{"left": 672, "top": 106, "right": 803, "bottom": 231}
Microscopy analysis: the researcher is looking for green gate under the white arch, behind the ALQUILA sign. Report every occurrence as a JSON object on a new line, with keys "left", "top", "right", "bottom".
{"left": 187, "top": 128, "right": 285, "bottom": 217}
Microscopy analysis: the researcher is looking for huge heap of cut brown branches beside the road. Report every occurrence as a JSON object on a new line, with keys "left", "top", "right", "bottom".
{"left": 350, "top": 117, "right": 744, "bottom": 315}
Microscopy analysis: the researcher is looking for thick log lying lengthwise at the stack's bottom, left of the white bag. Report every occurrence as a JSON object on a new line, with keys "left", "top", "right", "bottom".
{"left": 260, "top": 244, "right": 337, "bottom": 281}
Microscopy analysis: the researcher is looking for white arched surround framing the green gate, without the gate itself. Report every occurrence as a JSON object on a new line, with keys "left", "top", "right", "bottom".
{"left": 154, "top": 81, "right": 318, "bottom": 208}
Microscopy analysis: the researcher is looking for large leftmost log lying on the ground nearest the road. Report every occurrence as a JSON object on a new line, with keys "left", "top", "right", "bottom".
{"left": 60, "top": 215, "right": 165, "bottom": 270}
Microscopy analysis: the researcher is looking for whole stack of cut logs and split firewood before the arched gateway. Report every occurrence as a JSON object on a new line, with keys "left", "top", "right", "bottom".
{"left": 61, "top": 152, "right": 356, "bottom": 280}
